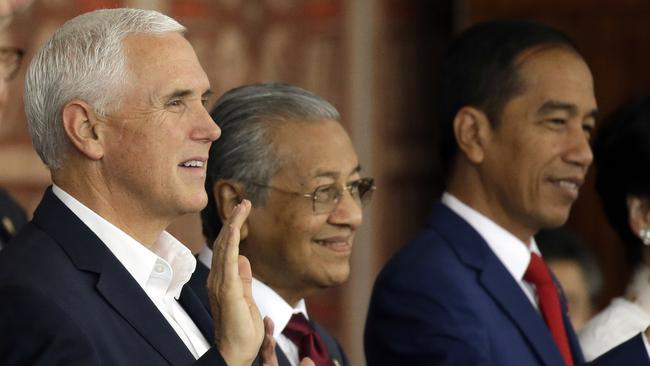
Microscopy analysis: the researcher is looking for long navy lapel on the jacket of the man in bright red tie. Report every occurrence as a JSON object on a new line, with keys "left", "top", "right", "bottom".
{"left": 429, "top": 203, "right": 570, "bottom": 365}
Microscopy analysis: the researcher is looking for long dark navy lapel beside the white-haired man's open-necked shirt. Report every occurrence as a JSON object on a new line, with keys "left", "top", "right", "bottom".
{"left": 33, "top": 187, "right": 194, "bottom": 365}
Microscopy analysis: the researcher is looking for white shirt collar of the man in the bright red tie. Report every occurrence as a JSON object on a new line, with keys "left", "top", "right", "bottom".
{"left": 442, "top": 192, "right": 540, "bottom": 282}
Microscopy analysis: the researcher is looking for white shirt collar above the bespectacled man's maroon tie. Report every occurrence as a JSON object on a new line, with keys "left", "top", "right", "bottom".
{"left": 253, "top": 278, "right": 309, "bottom": 338}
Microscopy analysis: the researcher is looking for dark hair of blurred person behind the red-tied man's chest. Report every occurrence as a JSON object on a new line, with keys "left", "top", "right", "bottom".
{"left": 535, "top": 228, "right": 603, "bottom": 304}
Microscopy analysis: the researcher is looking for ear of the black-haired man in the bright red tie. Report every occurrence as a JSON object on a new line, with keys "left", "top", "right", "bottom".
{"left": 454, "top": 106, "right": 492, "bottom": 164}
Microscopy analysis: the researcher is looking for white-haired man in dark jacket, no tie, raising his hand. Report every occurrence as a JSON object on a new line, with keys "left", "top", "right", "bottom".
{"left": 0, "top": 9, "right": 272, "bottom": 365}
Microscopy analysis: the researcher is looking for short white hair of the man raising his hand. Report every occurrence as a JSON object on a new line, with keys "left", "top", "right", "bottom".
{"left": 25, "top": 9, "right": 185, "bottom": 169}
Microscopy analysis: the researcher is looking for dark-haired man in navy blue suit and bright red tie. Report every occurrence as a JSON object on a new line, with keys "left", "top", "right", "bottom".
{"left": 365, "top": 21, "right": 650, "bottom": 366}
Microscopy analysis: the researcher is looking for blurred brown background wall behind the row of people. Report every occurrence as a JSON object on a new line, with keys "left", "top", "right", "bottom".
{"left": 0, "top": 0, "right": 650, "bottom": 365}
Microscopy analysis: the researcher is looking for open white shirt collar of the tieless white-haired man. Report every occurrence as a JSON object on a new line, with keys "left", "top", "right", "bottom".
{"left": 52, "top": 184, "right": 196, "bottom": 299}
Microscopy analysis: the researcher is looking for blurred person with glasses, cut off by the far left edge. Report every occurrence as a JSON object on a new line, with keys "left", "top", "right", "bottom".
{"left": 0, "top": 0, "right": 33, "bottom": 250}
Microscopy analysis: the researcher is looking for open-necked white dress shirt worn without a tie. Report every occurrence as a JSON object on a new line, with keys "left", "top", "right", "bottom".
{"left": 52, "top": 185, "right": 210, "bottom": 359}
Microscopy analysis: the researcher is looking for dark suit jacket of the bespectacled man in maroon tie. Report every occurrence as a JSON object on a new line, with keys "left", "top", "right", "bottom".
{"left": 187, "top": 261, "right": 350, "bottom": 366}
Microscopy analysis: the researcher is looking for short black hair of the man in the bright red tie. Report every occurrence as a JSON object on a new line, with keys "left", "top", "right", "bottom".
{"left": 436, "top": 20, "right": 580, "bottom": 179}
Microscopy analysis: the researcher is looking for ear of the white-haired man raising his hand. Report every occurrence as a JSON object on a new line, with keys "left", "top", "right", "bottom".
{"left": 62, "top": 99, "right": 104, "bottom": 160}
